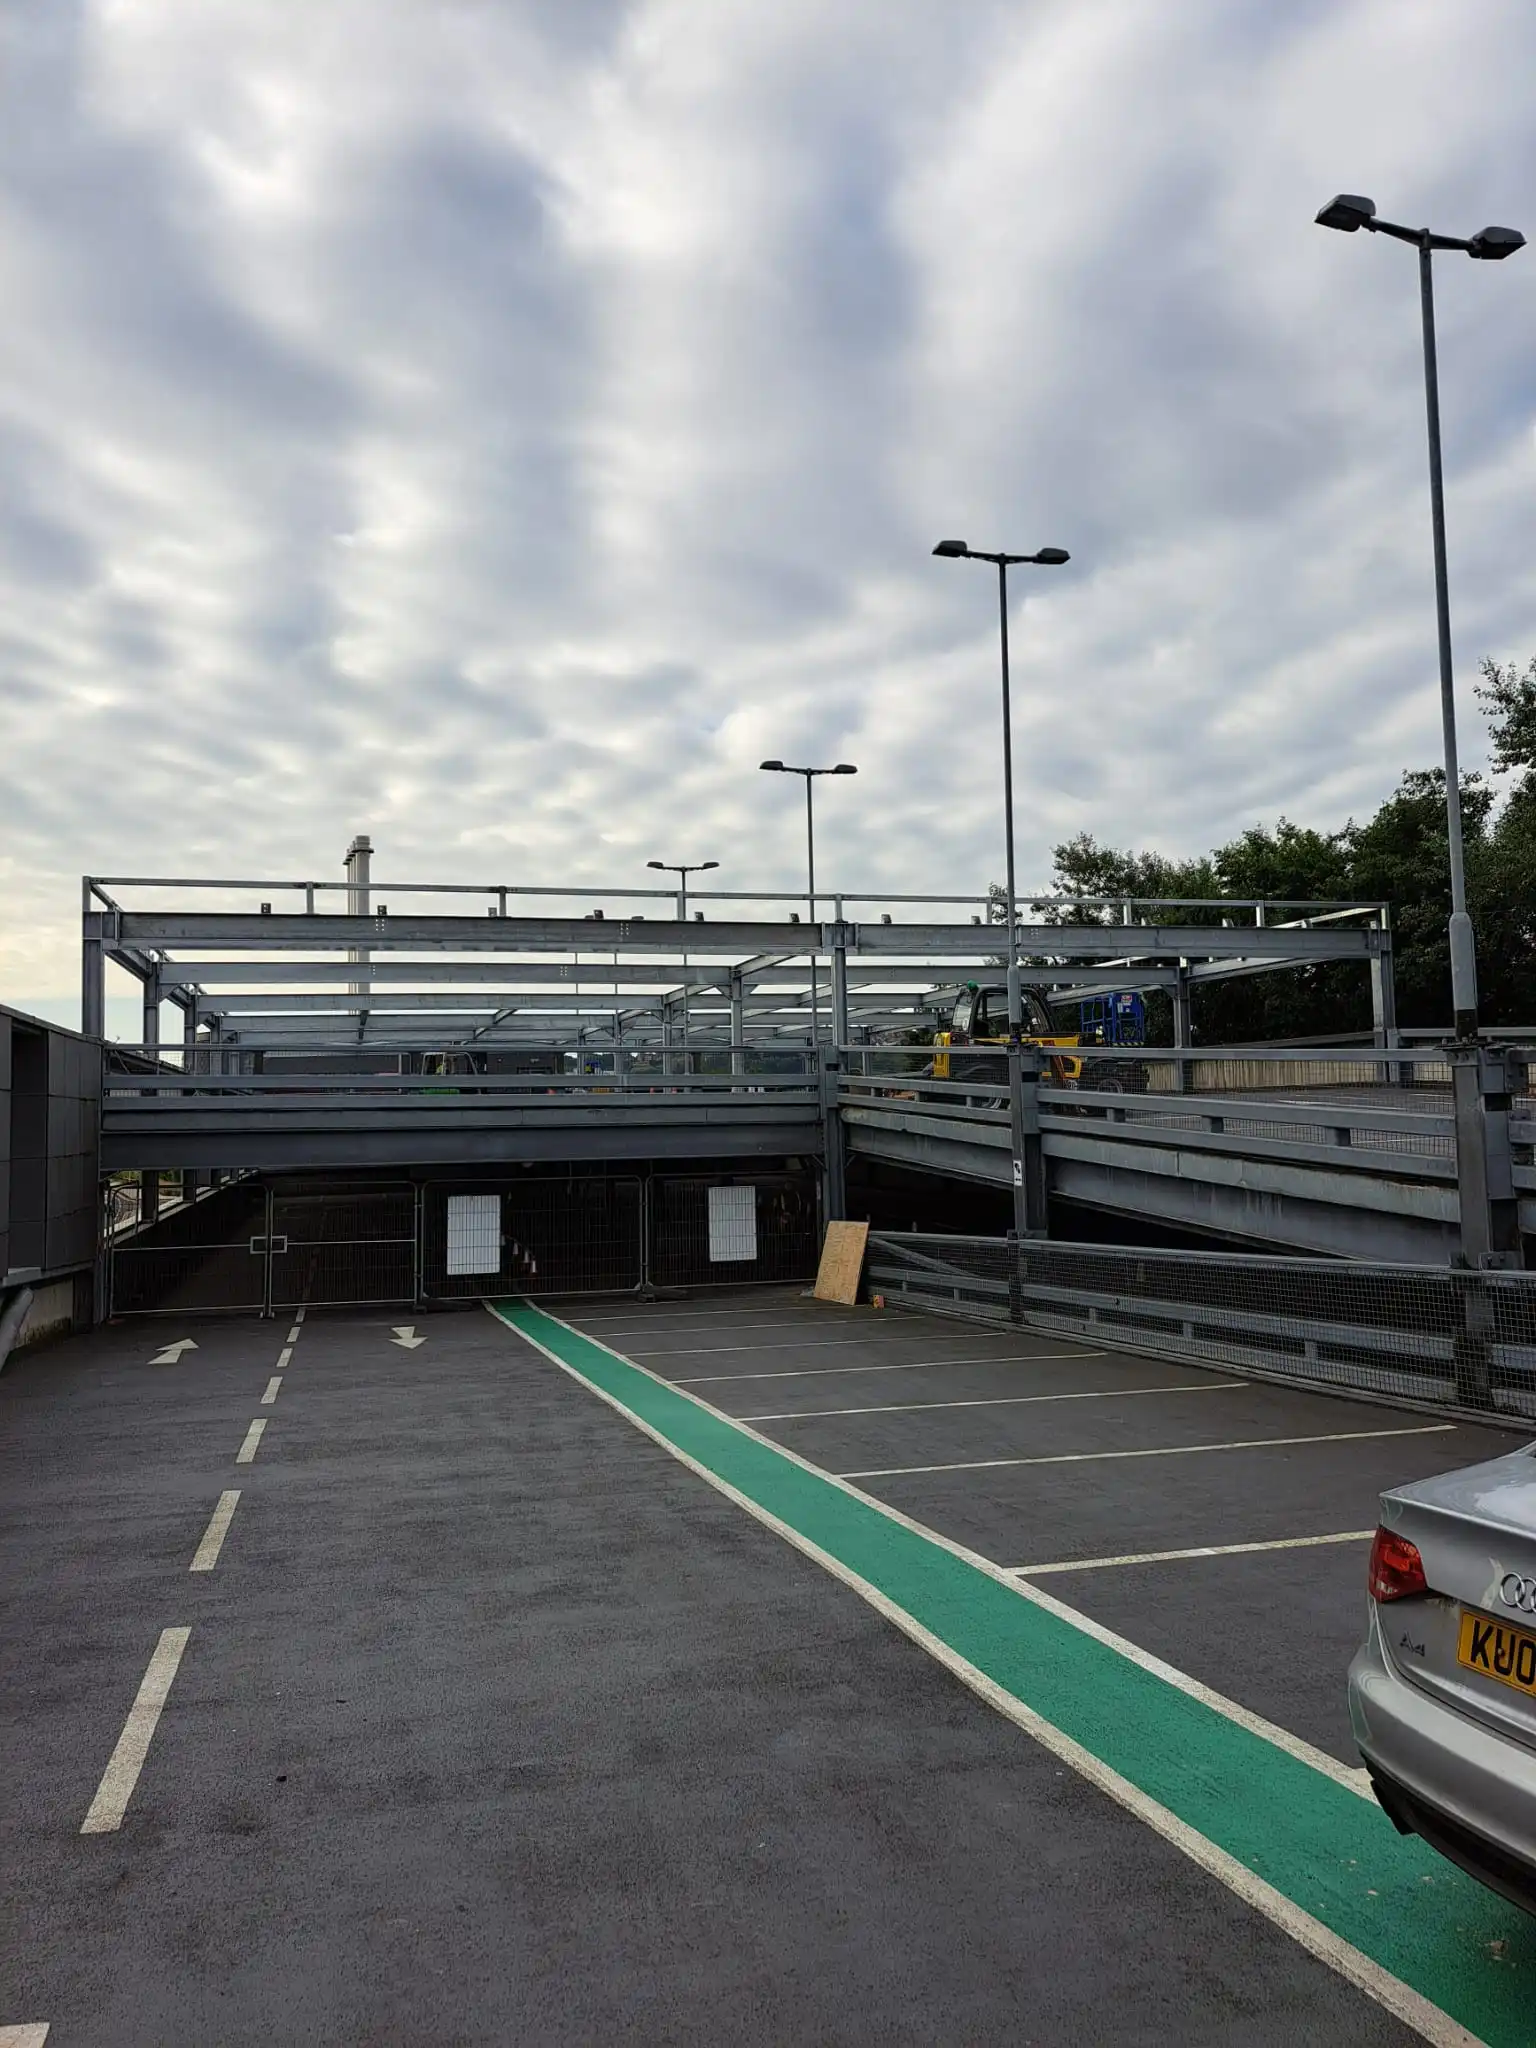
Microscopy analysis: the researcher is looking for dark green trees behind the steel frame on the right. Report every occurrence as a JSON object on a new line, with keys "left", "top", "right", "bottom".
{"left": 1047, "top": 675, "right": 1536, "bottom": 1044}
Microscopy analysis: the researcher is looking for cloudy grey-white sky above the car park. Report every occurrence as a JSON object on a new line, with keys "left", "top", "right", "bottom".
{"left": 0, "top": 0, "right": 1536, "bottom": 1020}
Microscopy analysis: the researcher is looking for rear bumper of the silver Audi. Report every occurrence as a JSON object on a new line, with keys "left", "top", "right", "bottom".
{"left": 1350, "top": 1610, "right": 1536, "bottom": 1913}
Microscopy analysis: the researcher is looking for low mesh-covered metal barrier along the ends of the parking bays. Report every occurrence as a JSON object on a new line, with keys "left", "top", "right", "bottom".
{"left": 866, "top": 1231, "right": 1536, "bottom": 1419}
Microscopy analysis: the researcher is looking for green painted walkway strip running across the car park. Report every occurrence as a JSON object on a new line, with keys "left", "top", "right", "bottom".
{"left": 494, "top": 1303, "right": 1536, "bottom": 2048}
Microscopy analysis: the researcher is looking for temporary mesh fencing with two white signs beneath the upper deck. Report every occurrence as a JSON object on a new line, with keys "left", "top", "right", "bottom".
{"left": 109, "top": 1171, "right": 819, "bottom": 1315}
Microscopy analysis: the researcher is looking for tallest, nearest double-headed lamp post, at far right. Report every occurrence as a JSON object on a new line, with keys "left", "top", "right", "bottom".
{"left": 1317, "top": 193, "right": 1526, "bottom": 1038}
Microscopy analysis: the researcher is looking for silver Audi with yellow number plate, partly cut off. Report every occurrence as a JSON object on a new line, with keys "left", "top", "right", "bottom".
{"left": 1350, "top": 1444, "right": 1536, "bottom": 1913}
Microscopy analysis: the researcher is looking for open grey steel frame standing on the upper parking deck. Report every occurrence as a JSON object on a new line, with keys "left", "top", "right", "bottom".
{"left": 82, "top": 877, "right": 1397, "bottom": 1071}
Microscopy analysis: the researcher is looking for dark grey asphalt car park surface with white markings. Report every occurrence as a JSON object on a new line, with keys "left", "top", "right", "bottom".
{"left": 0, "top": 1290, "right": 1511, "bottom": 2048}
